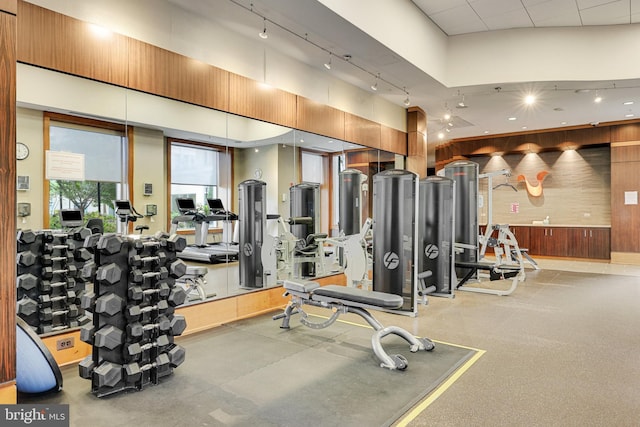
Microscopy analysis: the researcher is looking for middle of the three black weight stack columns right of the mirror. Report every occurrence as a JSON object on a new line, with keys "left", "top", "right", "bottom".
{"left": 418, "top": 176, "right": 455, "bottom": 296}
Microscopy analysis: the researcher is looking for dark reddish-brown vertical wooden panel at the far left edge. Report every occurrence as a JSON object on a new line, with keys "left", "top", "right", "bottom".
{"left": 0, "top": 6, "right": 17, "bottom": 384}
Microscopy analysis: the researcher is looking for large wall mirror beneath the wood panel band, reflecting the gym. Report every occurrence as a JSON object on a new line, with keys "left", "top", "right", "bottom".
{"left": 17, "top": 64, "right": 404, "bottom": 338}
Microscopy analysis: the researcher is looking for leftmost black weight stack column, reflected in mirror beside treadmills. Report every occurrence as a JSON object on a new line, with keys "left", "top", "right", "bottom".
{"left": 238, "top": 179, "right": 267, "bottom": 288}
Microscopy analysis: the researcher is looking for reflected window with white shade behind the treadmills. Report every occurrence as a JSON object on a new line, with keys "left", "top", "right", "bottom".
{"left": 170, "top": 139, "right": 229, "bottom": 229}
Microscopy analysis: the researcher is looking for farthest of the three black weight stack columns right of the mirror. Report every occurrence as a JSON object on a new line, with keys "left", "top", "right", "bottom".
{"left": 444, "top": 160, "right": 479, "bottom": 277}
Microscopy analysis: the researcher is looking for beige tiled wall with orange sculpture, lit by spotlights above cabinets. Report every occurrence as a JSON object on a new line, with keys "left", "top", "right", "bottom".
{"left": 476, "top": 147, "right": 611, "bottom": 226}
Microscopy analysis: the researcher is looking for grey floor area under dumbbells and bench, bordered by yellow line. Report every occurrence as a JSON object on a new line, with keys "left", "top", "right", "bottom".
{"left": 20, "top": 315, "right": 475, "bottom": 427}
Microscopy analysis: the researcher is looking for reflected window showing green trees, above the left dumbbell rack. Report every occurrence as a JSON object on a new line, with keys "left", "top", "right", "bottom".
{"left": 47, "top": 118, "right": 128, "bottom": 232}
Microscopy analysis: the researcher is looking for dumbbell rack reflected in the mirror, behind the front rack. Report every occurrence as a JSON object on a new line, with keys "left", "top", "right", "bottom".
{"left": 16, "top": 228, "right": 95, "bottom": 334}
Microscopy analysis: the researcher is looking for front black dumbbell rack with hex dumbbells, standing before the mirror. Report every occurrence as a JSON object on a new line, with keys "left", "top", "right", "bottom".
{"left": 79, "top": 234, "right": 187, "bottom": 397}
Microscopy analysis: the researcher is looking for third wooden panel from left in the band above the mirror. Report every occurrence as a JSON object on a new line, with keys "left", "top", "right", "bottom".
{"left": 229, "top": 73, "right": 297, "bottom": 128}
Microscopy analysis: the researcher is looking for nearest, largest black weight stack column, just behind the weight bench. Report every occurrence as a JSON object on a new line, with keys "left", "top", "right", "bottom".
{"left": 373, "top": 169, "right": 418, "bottom": 313}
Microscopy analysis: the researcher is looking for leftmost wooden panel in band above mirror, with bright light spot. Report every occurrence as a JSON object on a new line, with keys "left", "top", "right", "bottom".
{"left": 18, "top": 1, "right": 129, "bottom": 86}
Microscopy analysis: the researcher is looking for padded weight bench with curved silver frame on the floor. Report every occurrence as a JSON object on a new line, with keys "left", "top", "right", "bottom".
{"left": 273, "top": 280, "right": 435, "bottom": 370}
